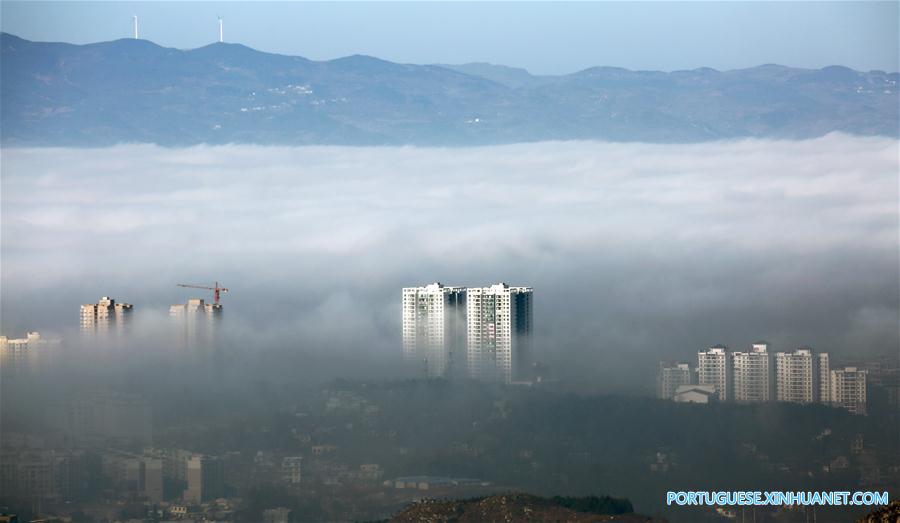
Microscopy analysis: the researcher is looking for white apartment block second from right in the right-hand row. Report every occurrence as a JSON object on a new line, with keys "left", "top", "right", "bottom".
{"left": 775, "top": 347, "right": 829, "bottom": 403}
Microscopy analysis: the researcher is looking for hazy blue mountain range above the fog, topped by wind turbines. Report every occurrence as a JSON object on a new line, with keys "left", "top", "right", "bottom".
{"left": 0, "top": 33, "right": 900, "bottom": 146}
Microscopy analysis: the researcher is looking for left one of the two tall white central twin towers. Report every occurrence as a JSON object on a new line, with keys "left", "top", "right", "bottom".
{"left": 403, "top": 283, "right": 466, "bottom": 378}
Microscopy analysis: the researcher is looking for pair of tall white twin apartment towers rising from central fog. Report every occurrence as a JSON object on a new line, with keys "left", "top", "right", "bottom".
{"left": 403, "top": 283, "right": 534, "bottom": 384}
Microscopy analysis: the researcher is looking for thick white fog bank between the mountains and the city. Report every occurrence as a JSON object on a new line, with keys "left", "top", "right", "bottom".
{"left": 0, "top": 134, "right": 900, "bottom": 392}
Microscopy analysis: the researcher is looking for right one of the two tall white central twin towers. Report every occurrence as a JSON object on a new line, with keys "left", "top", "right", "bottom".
{"left": 466, "top": 283, "right": 532, "bottom": 383}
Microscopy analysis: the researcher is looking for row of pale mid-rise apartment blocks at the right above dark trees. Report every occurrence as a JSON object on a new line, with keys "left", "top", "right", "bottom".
{"left": 657, "top": 342, "right": 868, "bottom": 414}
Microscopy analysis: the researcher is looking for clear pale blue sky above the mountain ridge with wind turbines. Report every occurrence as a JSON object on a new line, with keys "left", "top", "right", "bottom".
{"left": 0, "top": 0, "right": 900, "bottom": 74}
